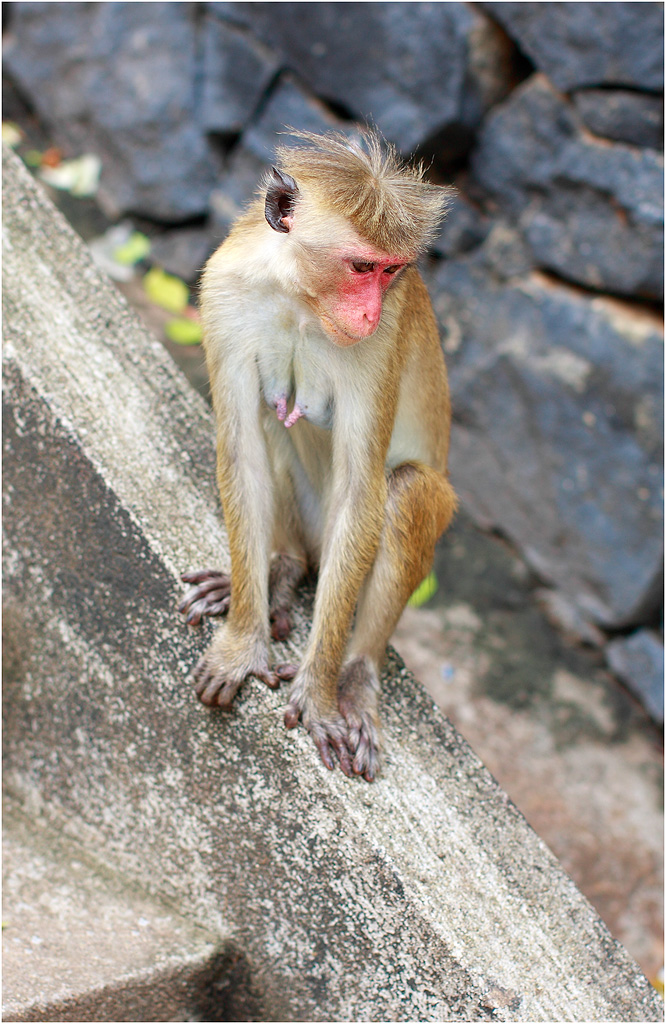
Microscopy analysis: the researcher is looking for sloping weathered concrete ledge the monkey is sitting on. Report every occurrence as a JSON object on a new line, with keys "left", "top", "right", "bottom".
{"left": 3, "top": 146, "right": 663, "bottom": 1021}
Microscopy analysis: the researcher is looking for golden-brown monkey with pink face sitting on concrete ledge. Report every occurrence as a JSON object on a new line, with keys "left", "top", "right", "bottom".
{"left": 179, "top": 129, "right": 457, "bottom": 781}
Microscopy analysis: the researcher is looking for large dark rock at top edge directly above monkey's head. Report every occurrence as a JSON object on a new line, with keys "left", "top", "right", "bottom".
{"left": 218, "top": 3, "right": 510, "bottom": 152}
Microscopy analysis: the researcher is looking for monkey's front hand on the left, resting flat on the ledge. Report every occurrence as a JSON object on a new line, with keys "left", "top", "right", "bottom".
{"left": 194, "top": 628, "right": 297, "bottom": 710}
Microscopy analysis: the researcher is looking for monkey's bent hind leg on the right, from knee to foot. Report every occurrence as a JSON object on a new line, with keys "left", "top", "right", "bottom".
{"left": 338, "top": 463, "right": 456, "bottom": 781}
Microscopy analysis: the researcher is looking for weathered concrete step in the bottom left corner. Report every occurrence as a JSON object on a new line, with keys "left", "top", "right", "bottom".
{"left": 2, "top": 799, "right": 234, "bottom": 1021}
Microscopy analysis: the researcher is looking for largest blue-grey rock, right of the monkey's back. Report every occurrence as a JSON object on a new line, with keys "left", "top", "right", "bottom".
{"left": 431, "top": 244, "right": 663, "bottom": 627}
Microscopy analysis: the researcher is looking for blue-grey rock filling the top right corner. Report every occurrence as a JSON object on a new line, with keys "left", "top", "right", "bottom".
{"left": 481, "top": 2, "right": 664, "bottom": 92}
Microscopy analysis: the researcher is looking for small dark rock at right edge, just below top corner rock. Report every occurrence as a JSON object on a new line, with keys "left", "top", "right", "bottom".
{"left": 572, "top": 89, "right": 664, "bottom": 151}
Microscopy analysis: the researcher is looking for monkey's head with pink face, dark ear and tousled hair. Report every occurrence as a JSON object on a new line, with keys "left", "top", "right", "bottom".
{"left": 264, "top": 132, "right": 450, "bottom": 346}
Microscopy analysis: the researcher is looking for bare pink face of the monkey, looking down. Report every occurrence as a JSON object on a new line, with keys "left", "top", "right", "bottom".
{"left": 318, "top": 249, "right": 408, "bottom": 347}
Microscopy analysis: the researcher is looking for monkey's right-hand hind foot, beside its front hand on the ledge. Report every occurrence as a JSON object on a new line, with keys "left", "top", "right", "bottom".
{"left": 338, "top": 657, "right": 381, "bottom": 782}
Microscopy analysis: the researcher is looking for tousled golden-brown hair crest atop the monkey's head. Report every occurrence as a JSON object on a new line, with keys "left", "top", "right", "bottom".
{"left": 277, "top": 129, "right": 452, "bottom": 258}
